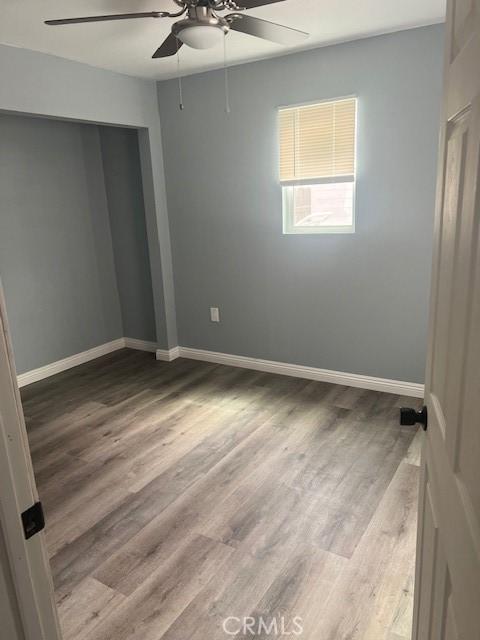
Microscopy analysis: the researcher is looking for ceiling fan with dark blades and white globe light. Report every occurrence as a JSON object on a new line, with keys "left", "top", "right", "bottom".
{"left": 45, "top": 0, "right": 308, "bottom": 58}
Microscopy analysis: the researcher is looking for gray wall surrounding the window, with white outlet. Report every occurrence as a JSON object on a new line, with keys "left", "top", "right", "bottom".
{"left": 158, "top": 26, "right": 443, "bottom": 382}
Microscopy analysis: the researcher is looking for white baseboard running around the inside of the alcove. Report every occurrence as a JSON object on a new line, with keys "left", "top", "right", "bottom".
{"left": 17, "top": 338, "right": 157, "bottom": 387}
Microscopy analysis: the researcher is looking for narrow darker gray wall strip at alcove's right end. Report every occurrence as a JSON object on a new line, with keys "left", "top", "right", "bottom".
{"left": 99, "top": 127, "right": 155, "bottom": 342}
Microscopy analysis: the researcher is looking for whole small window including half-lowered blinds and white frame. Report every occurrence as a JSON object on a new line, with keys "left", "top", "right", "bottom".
{"left": 279, "top": 98, "right": 357, "bottom": 233}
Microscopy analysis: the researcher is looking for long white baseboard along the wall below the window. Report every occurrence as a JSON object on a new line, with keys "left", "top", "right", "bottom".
{"left": 175, "top": 347, "right": 424, "bottom": 398}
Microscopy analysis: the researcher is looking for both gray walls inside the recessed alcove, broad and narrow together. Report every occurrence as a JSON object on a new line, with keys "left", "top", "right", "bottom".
{"left": 0, "top": 115, "right": 156, "bottom": 373}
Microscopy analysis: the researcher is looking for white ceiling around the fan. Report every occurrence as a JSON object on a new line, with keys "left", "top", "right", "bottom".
{"left": 0, "top": 0, "right": 446, "bottom": 79}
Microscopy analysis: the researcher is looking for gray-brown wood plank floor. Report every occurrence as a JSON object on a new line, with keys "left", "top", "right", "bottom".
{"left": 22, "top": 350, "right": 419, "bottom": 640}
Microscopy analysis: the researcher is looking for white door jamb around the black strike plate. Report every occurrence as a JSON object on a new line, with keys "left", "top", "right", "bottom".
{"left": 0, "top": 281, "right": 61, "bottom": 640}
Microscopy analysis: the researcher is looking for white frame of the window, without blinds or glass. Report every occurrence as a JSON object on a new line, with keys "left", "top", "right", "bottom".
{"left": 277, "top": 94, "right": 358, "bottom": 235}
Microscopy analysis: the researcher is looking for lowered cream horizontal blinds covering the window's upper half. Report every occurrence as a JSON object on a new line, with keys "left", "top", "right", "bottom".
{"left": 279, "top": 98, "right": 357, "bottom": 183}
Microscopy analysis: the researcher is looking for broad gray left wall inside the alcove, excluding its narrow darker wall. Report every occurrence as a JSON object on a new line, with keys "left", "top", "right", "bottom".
{"left": 0, "top": 115, "right": 123, "bottom": 373}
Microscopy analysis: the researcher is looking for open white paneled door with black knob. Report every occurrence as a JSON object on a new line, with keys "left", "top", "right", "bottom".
{"left": 413, "top": 0, "right": 480, "bottom": 640}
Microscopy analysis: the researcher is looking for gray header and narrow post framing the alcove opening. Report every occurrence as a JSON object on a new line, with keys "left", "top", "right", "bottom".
{"left": 0, "top": 45, "right": 177, "bottom": 348}
